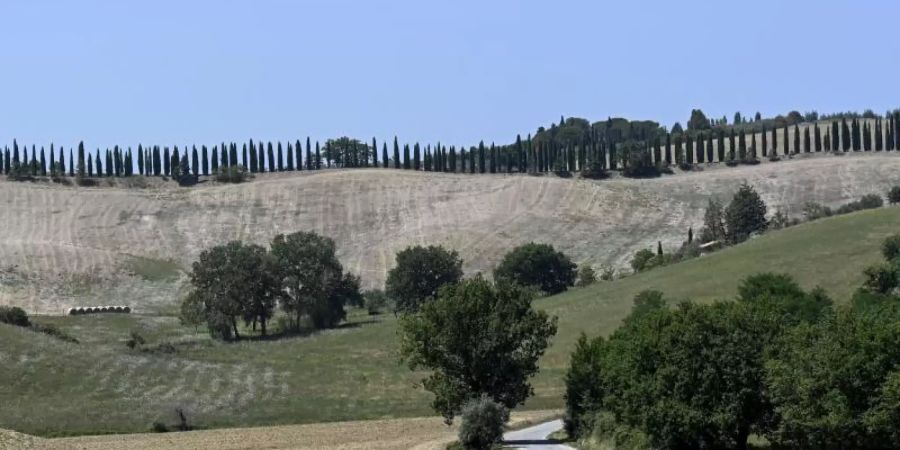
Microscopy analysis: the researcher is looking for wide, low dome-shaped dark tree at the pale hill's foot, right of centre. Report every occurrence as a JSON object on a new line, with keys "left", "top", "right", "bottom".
{"left": 494, "top": 242, "right": 576, "bottom": 295}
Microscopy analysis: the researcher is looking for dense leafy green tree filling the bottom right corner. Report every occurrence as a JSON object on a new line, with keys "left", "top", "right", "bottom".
{"left": 766, "top": 303, "right": 900, "bottom": 450}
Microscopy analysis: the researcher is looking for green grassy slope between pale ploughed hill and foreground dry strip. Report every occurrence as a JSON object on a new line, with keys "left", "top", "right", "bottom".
{"left": 0, "top": 208, "right": 900, "bottom": 435}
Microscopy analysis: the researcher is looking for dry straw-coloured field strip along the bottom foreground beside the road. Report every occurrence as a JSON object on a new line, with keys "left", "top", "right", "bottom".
{"left": 0, "top": 411, "right": 560, "bottom": 450}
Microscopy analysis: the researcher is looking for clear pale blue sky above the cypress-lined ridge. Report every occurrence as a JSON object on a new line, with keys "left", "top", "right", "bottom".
{"left": 0, "top": 0, "right": 900, "bottom": 149}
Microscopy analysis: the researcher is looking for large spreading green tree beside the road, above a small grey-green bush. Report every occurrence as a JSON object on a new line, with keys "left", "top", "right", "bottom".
{"left": 400, "top": 276, "right": 556, "bottom": 423}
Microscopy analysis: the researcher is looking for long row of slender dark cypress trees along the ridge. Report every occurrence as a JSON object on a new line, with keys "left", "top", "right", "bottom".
{"left": 0, "top": 112, "right": 900, "bottom": 177}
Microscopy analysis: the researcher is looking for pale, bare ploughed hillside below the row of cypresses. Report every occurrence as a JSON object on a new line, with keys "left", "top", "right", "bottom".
{"left": 0, "top": 152, "right": 900, "bottom": 314}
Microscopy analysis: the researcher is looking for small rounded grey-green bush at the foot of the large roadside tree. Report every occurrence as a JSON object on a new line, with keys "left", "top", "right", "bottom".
{"left": 459, "top": 395, "right": 509, "bottom": 450}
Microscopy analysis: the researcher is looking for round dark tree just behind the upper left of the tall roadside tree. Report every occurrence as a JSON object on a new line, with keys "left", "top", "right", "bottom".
{"left": 385, "top": 245, "right": 463, "bottom": 313}
